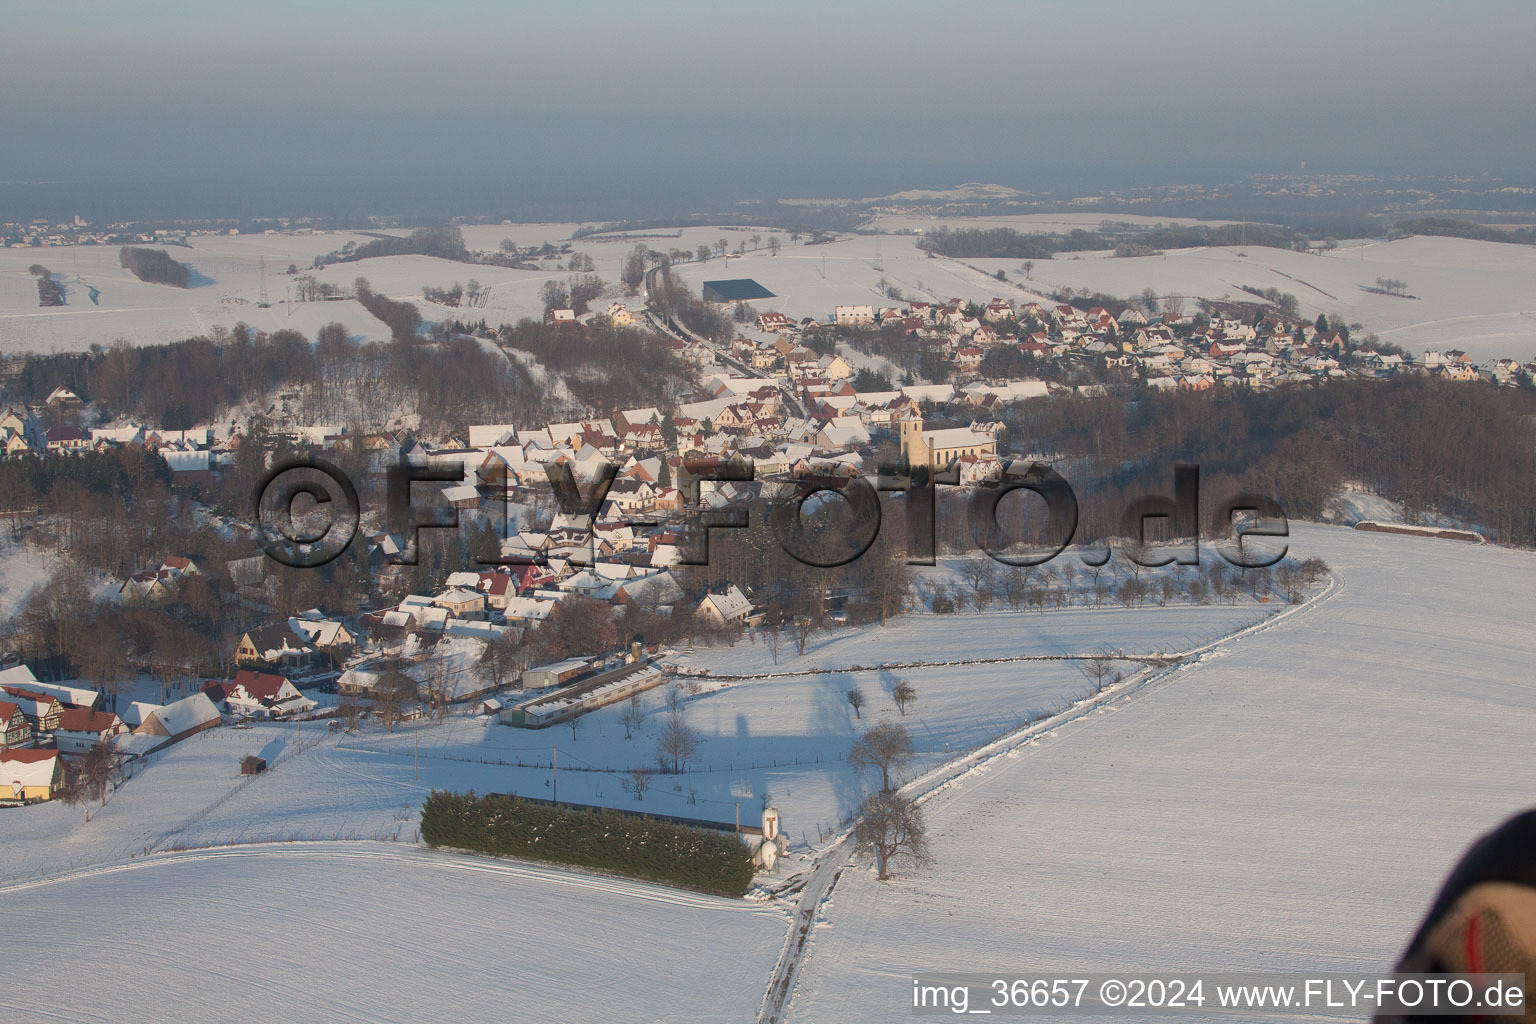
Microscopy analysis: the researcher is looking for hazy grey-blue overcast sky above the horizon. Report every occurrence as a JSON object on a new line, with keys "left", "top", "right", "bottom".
{"left": 0, "top": 0, "right": 1536, "bottom": 191}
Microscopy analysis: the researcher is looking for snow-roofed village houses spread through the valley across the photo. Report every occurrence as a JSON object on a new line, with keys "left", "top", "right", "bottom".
{"left": 0, "top": 280, "right": 1536, "bottom": 772}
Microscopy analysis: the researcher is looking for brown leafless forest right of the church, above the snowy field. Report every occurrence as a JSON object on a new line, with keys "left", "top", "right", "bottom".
{"left": 1005, "top": 378, "right": 1536, "bottom": 547}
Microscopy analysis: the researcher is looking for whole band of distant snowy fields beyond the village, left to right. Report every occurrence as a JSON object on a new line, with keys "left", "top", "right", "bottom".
{"left": 9, "top": 222, "right": 1536, "bottom": 359}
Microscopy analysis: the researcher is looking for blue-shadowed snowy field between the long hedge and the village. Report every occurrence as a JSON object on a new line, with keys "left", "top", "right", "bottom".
{"left": 0, "top": 592, "right": 1273, "bottom": 881}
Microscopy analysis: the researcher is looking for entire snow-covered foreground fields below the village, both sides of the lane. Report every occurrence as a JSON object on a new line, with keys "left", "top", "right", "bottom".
{"left": 0, "top": 524, "right": 1536, "bottom": 1021}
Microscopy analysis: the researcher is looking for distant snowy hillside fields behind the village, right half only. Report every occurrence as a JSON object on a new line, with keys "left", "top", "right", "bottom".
{"left": 680, "top": 227, "right": 1536, "bottom": 361}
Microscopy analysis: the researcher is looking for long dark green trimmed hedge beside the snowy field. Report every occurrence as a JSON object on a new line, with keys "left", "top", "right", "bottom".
{"left": 421, "top": 791, "right": 753, "bottom": 897}
